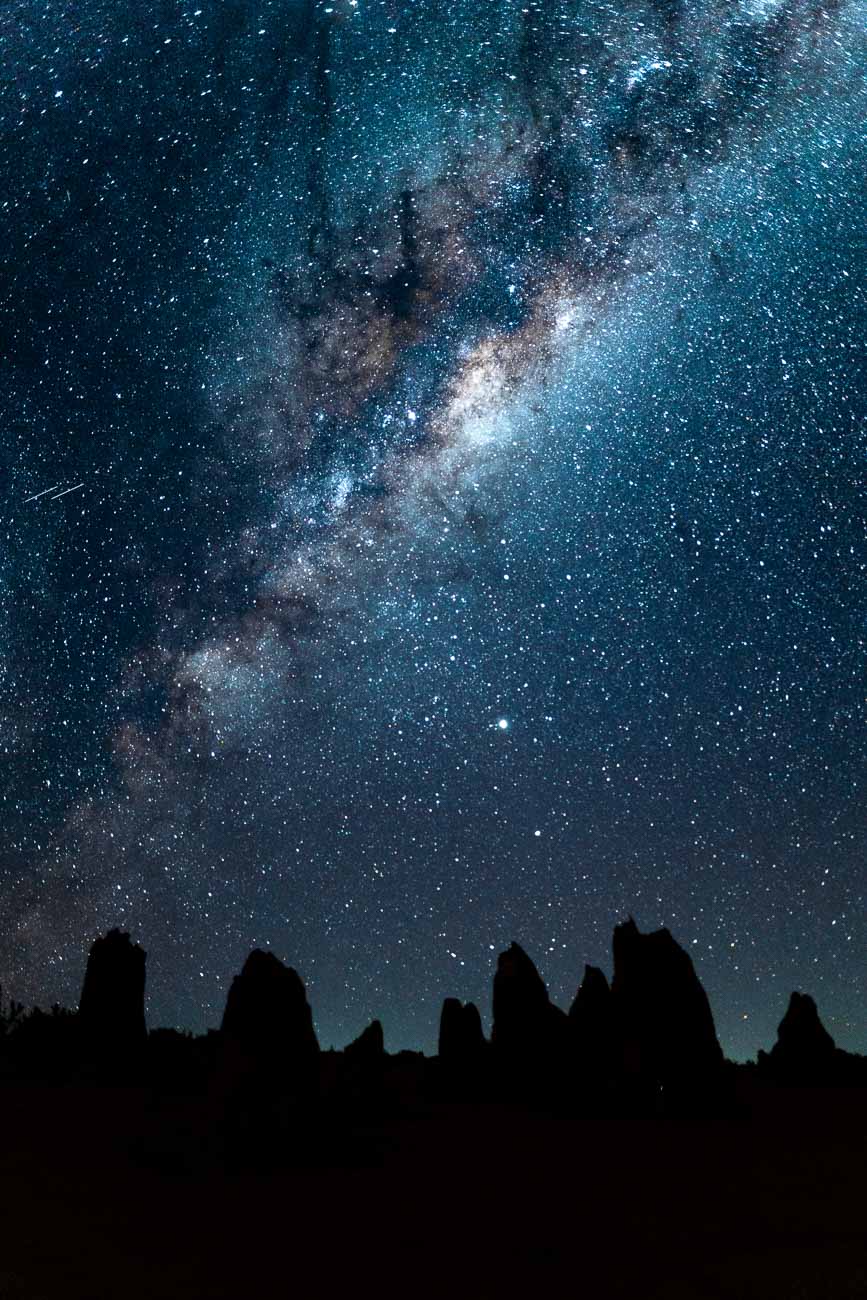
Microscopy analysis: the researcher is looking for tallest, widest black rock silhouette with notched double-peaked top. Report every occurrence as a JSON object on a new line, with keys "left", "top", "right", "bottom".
{"left": 611, "top": 918, "right": 723, "bottom": 1092}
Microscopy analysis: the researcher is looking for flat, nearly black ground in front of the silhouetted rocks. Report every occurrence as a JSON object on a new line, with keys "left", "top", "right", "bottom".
{"left": 0, "top": 1083, "right": 867, "bottom": 1300}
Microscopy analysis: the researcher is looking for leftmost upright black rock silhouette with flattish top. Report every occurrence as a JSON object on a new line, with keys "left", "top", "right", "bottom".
{"left": 78, "top": 930, "right": 147, "bottom": 1058}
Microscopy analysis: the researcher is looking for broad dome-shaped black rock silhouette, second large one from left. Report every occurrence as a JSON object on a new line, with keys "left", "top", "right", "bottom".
{"left": 221, "top": 949, "right": 320, "bottom": 1091}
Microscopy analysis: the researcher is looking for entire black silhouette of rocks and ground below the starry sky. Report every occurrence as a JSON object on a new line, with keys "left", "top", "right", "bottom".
{"left": 0, "top": 922, "right": 867, "bottom": 1300}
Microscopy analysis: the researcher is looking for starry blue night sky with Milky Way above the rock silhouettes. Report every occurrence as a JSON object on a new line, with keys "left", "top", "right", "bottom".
{"left": 0, "top": 0, "right": 867, "bottom": 1058}
